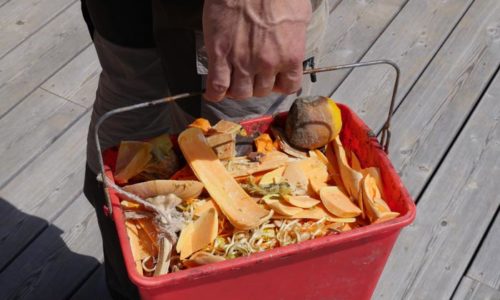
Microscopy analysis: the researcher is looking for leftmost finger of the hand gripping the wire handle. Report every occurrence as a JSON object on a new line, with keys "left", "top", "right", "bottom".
{"left": 203, "top": 60, "right": 231, "bottom": 101}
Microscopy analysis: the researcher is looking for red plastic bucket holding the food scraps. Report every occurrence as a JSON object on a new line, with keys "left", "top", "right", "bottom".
{"left": 104, "top": 104, "right": 415, "bottom": 300}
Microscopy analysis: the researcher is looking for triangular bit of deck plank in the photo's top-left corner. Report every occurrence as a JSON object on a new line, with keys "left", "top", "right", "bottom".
{"left": 0, "top": 0, "right": 75, "bottom": 57}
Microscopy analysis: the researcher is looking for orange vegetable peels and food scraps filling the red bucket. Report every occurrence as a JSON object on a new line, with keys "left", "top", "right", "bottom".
{"left": 115, "top": 96, "right": 399, "bottom": 276}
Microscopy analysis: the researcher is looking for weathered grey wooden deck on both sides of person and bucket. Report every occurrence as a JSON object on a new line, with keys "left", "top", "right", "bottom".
{"left": 0, "top": 0, "right": 500, "bottom": 299}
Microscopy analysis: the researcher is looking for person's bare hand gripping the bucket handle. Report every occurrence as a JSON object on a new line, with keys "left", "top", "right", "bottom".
{"left": 203, "top": 0, "right": 311, "bottom": 101}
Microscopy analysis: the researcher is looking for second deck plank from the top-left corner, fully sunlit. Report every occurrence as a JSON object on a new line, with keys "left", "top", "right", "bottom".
{"left": 0, "top": 1, "right": 90, "bottom": 116}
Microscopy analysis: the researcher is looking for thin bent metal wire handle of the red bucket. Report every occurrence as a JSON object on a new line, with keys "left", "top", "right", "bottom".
{"left": 94, "top": 60, "right": 400, "bottom": 215}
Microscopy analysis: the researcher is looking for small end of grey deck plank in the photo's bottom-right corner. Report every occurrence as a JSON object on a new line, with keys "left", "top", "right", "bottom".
{"left": 453, "top": 276, "right": 500, "bottom": 300}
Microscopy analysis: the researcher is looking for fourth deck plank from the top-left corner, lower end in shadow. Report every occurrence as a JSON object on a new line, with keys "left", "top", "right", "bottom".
{"left": 0, "top": 113, "right": 90, "bottom": 270}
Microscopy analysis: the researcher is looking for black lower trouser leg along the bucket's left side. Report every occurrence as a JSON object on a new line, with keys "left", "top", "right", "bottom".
{"left": 83, "top": 166, "right": 139, "bottom": 299}
